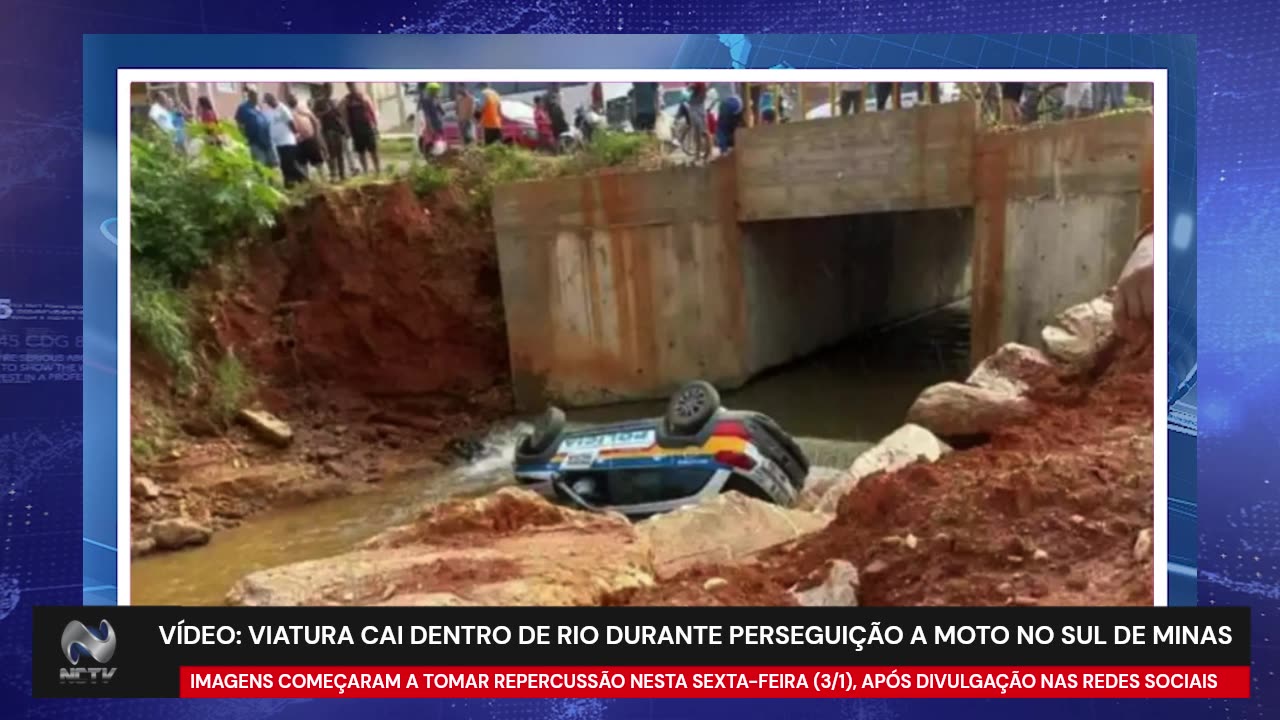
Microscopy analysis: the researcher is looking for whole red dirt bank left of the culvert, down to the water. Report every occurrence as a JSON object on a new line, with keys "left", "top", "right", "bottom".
{"left": 133, "top": 182, "right": 511, "bottom": 542}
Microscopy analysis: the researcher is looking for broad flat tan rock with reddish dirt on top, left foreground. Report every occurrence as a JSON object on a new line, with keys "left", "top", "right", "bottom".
{"left": 228, "top": 488, "right": 653, "bottom": 606}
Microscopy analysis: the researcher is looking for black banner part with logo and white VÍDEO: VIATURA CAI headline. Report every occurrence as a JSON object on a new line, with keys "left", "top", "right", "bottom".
{"left": 32, "top": 606, "right": 1251, "bottom": 697}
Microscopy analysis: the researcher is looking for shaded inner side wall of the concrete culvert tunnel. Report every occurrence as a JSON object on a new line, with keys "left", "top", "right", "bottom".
{"left": 742, "top": 210, "right": 973, "bottom": 374}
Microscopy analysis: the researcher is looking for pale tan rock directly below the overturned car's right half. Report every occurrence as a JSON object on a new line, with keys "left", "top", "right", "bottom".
{"left": 636, "top": 492, "right": 832, "bottom": 578}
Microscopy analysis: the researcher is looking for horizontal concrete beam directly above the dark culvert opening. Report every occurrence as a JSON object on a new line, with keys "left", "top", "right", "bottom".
{"left": 733, "top": 102, "right": 975, "bottom": 222}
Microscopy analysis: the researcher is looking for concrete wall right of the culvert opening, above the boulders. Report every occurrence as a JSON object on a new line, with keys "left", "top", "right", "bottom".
{"left": 972, "top": 113, "right": 1155, "bottom": 361}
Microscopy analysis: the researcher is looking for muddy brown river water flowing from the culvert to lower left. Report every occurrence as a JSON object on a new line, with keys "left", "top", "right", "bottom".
{"left": 132, "top": 304, "right": 969, "bottom": 605}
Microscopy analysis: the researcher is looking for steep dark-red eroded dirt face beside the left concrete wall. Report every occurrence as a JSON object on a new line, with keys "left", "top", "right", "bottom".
{"left": 214, "top": 183, "right": 507, "bottom": 400}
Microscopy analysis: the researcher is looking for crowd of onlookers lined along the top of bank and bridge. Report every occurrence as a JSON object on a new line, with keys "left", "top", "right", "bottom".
{"left": 148, "top": 82, "right": 1128, "bottom": 186}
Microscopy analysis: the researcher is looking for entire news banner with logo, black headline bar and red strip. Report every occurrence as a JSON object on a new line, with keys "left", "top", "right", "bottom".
{"left": 32, "top": 606, "right": 1251, "bottom": 698}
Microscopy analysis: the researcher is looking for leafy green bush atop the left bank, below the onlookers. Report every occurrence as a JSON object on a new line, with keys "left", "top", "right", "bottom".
{"left": 129, "top": 123, "right": 285, "bottom": 284}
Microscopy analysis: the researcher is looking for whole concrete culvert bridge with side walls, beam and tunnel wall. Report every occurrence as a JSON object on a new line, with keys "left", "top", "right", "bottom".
{"left": 494, "top": 102, "right": 1153, "bottom": 409}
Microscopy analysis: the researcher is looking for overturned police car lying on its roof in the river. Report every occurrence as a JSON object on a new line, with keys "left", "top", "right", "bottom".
{"left": 515, "top": 380, "right": 809, "bottom": 518}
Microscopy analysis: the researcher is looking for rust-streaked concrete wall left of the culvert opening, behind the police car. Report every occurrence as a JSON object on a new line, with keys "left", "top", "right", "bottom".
{"left": 494, "top": 165, "right": 745, "bottom": 409}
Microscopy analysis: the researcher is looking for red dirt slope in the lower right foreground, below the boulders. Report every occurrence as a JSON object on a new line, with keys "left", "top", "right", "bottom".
{"left": 611, "top": 338, "right": 1153, "bottom": 605}
